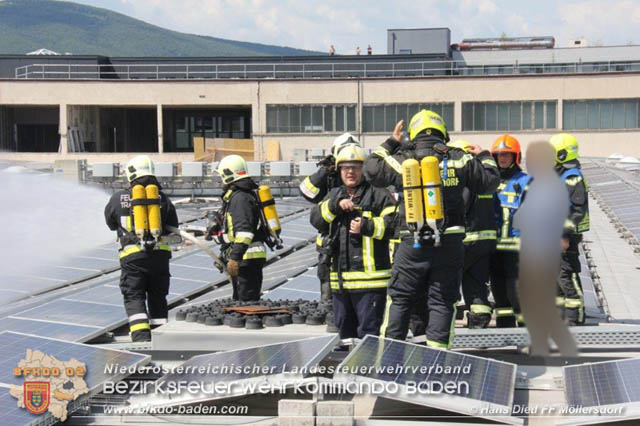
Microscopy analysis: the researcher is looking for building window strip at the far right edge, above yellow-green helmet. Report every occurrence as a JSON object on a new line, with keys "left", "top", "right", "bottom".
{"left": 562, "top": 99, "right": 640, "bottom": 130}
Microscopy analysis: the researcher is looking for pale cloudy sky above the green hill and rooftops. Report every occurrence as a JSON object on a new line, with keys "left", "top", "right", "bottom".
{"left": 69, "top": 0, "right": 640, "bottom": 54}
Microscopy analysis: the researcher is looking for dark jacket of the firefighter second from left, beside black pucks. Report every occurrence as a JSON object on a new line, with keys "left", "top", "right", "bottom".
{"left": 222, "top": 178, "right": 267, "bottom": 266}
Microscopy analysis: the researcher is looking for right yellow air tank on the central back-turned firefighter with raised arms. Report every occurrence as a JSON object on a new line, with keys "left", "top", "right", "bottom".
{"left": 420, "top": 155, "right": 444, "bottom": 246}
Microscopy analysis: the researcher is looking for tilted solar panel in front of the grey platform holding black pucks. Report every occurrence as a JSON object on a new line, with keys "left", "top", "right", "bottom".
{"left": 132, "top": 335, "right": 339, "bottom": 406}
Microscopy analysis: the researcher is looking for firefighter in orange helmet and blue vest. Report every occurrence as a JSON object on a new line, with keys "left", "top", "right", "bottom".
{"left": 490, "top": 135, "right": 531, "bottom": 328}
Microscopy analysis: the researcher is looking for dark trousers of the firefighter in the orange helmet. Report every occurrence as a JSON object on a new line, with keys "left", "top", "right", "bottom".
{"left": 490, "top": 250, "right": 520, "bottom": 328}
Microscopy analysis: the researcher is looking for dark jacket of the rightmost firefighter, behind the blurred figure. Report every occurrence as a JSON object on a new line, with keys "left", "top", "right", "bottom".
{"left": 556, "top": 160, "right": 589, "bottom": 237}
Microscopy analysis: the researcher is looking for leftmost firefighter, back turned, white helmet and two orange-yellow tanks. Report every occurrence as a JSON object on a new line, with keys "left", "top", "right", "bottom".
{"left": 104, "top": 155, "right": 178, "bottom": 342}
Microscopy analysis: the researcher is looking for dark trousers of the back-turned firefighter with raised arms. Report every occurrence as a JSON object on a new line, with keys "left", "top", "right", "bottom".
{"left": 380, "top": 234, "right": 464, "bottom": 348}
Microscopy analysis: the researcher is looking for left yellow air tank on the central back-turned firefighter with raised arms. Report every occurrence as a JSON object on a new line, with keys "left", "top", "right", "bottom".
{"left": 402, "top": 158, "right": 424, "bottom": 248}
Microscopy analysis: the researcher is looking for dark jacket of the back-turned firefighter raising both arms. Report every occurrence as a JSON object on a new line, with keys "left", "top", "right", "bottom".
{"left": 366, "top": 136, "right": 500, "bottom": 236}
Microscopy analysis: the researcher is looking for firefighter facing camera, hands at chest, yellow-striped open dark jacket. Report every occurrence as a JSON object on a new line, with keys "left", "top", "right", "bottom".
{"left": 311, "top": 144, "right": 396, "bottom": 339}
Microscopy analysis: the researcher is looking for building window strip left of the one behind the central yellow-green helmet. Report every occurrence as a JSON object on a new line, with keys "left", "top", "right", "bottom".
{"left": 267, "top": 105, "right": 356, "bottom": 133}
